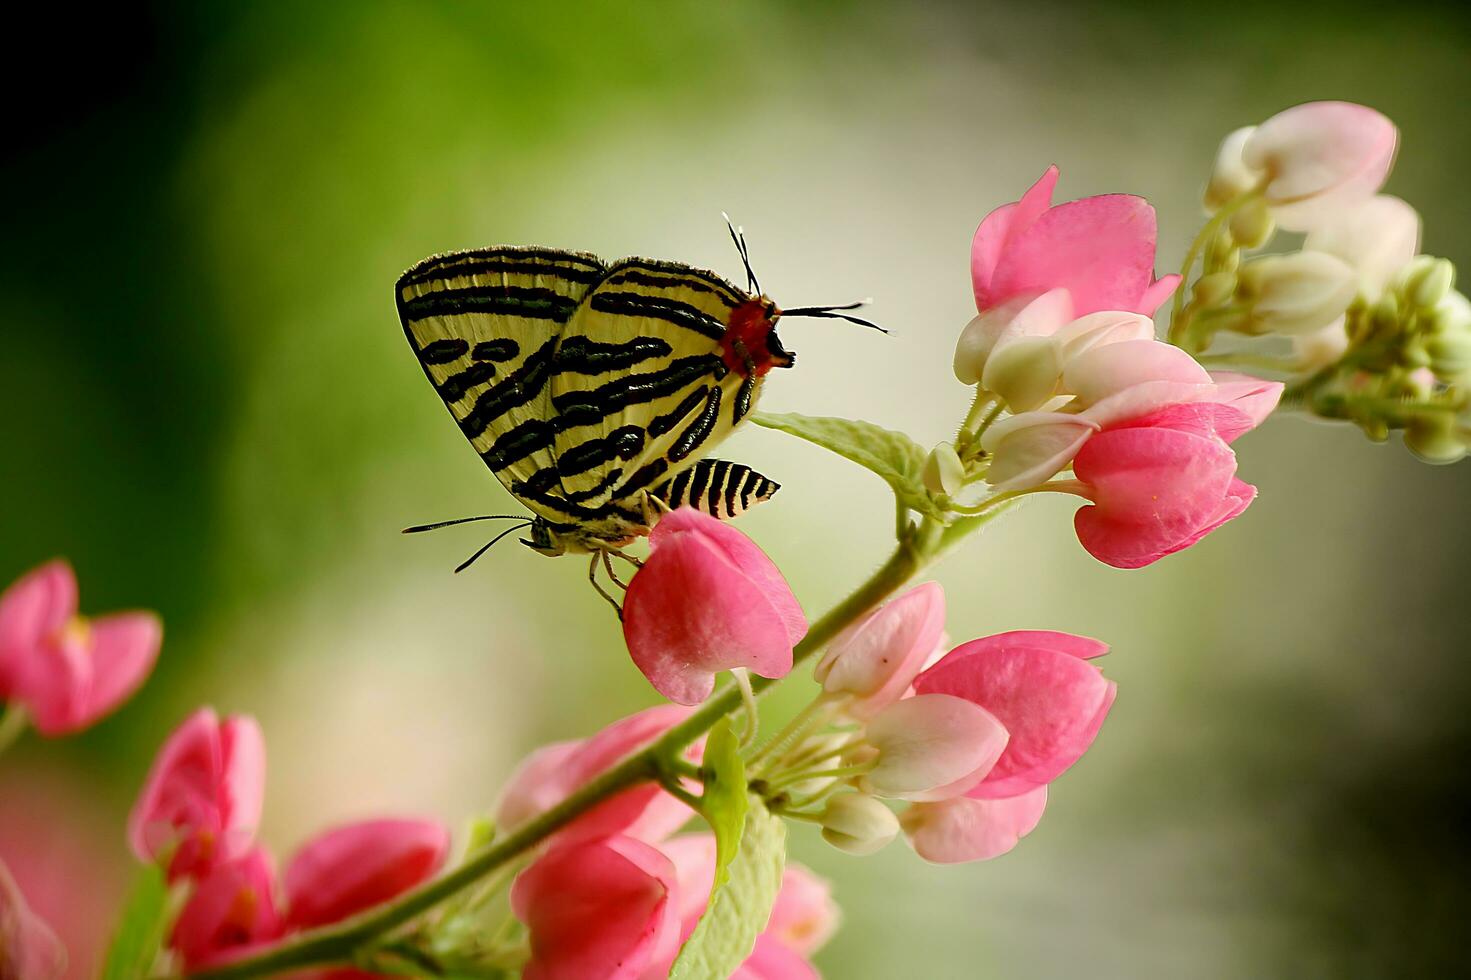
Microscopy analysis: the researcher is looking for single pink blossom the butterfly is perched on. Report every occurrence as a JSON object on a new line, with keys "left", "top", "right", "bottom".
{"left": 624, "top": 508, "right": 808, "bottom": 705}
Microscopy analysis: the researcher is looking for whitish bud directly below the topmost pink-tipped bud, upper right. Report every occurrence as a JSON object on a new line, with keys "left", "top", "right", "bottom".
{"left": 1302, "top": 194, "right": 1420, "bottom": 295}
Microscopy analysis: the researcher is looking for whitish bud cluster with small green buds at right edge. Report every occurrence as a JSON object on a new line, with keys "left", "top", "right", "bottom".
{"left": 1171, "top": 102, "right": 1471, "bottom": 462}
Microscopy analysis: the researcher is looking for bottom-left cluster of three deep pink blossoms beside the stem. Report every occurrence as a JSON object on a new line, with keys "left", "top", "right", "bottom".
{"left": 128, "top": 708, "right": 449, "bottom": 970}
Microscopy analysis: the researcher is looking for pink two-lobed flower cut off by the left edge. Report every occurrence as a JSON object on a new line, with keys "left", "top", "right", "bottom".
{"left": 0, "top": 561, "right": 163, "bottom": 736}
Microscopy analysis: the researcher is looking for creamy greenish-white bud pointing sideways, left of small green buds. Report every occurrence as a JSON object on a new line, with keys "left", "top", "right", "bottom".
{"left": 1239, "top": 252, "right": 1358, "bottom": 335}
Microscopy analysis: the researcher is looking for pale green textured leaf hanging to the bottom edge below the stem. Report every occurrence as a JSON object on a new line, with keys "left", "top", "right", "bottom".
{"left": 669, "top": 788, "right": 787, "bottom": 980}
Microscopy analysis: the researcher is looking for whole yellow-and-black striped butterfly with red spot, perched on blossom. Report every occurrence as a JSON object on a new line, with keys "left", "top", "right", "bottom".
{"left": 394, "top": 228, "right": 881, "bottom": 605}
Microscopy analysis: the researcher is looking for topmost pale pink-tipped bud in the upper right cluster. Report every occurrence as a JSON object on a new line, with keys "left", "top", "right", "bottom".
{"left": 1242, "top": 102, "right": 1399, "bottom": 231}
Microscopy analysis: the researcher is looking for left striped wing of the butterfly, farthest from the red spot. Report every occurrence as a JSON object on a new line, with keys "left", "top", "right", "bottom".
{"left": 394, "top": 247, "right": 606, "bottom": 519}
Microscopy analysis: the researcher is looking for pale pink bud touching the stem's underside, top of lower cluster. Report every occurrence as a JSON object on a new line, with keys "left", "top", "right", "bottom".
{"left": 813, "top": 581, "right": 944, "bottom": 718}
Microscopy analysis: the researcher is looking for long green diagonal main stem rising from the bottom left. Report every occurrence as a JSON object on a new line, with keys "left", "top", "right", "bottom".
{"left": 190, "top": 518, "right": 935, "bottom": 980}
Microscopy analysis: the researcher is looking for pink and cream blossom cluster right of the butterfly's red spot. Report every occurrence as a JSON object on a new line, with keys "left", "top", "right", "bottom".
{"left": 931, "top": 168, "right": 1281, "bottom": 568}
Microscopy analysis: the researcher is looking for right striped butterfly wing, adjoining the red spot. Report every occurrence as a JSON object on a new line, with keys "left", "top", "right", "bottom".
{"left": 552, "top": 259, "right": 761, "bottom": 508}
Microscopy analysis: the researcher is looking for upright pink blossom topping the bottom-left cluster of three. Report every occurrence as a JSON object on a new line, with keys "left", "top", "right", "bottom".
{"left": 128, "top": 708, "right": 266, "bottom": 880}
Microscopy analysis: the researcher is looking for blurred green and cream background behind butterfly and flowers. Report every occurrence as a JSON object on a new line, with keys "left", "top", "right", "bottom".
{"left": 0, "top": 0, "right": 1471, "bottom": 979}
